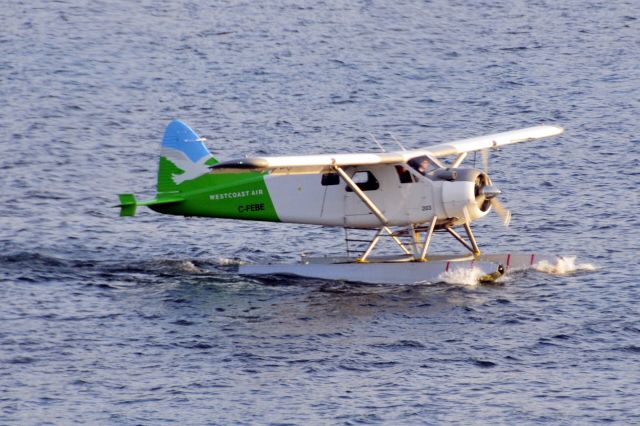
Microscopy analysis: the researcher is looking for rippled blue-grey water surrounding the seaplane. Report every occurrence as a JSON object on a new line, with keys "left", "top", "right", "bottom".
{"left": 0, "top": 0, "right": 640, "bottom": 424}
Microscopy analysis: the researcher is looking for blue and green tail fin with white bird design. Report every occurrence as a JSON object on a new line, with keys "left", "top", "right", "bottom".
{"left": 158, "top": 120, "right": 218, "bottom": 194}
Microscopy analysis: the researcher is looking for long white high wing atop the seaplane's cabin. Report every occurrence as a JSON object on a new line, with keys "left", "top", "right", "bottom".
{"left": 211, "top": 125, "right": 564, "bottom": 174}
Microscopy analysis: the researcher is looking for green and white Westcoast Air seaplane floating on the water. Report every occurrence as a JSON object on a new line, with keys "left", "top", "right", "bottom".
{"left": 116, "top": 120, "right": 564, "bottom": 284}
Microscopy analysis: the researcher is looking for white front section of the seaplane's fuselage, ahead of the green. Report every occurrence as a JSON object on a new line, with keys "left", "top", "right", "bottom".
{"left": 265, "top": 165, "right": 487, "bottom": 228}
